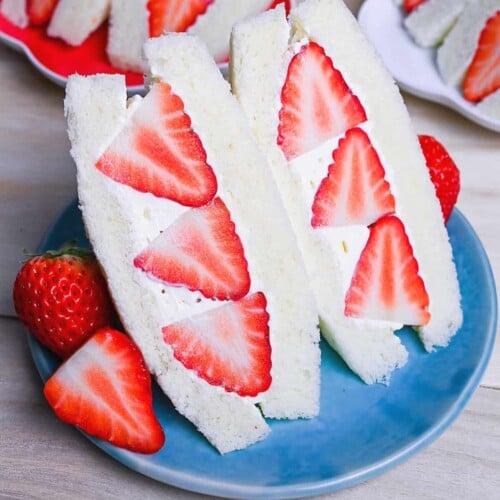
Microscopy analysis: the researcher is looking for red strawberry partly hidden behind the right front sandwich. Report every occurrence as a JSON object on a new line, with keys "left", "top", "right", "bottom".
{"left": 418, "top": 135, "right": 460, "bottom": 223}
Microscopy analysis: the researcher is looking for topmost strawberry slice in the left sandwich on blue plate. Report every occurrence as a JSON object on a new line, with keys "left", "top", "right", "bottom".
{"left": 96, "top": 83, "right": 217, "bottom": 207}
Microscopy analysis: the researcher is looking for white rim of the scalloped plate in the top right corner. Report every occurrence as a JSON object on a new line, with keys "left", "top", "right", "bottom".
{"left": 357, "top": 0, "right": 500, "bottom": 132}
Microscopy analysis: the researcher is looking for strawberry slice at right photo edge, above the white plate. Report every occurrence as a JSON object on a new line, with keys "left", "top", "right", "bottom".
{"left": 463, "top": 10, "right": 500, "bottom": 102}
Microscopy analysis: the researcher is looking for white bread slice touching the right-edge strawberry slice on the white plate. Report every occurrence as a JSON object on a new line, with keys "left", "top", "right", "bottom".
{"left": 437, "top": 0, "right": 500, "bottom": 87}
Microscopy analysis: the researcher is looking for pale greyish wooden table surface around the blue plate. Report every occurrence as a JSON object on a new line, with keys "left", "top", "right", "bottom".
{"left": 0, "top": 0, "right": 500, "bottom": 500}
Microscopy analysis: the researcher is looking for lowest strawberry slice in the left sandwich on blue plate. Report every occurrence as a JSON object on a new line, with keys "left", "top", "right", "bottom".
{"left": 163, "top": 292, "right": 271, "bottom": 396}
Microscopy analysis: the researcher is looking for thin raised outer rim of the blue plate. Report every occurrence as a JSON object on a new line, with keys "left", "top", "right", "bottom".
{"left": 26, "top": 198, "right": 498, "bottom": 499}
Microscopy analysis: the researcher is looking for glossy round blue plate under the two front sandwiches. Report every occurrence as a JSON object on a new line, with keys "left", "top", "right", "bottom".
{"left": 28, "top": 201, "right": 497, "bottom": 499}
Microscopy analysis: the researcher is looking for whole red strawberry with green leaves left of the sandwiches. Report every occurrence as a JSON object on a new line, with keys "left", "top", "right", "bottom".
{"left": 13, "top": 248, "right": 114, "bottom": 359}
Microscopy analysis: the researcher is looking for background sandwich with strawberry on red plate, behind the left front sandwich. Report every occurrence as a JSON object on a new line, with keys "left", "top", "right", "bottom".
{"left": 107, "top": 0, "right": 290, "bottom": 71}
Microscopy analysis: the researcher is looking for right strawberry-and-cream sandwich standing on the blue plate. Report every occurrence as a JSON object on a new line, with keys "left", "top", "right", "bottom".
{"left": 230, "top": 0, "right": 462, "bottom": 383}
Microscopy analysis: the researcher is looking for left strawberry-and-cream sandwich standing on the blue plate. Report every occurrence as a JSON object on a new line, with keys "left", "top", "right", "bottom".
{"left": 65, "top": 34, "right": 320, "bottom": 453}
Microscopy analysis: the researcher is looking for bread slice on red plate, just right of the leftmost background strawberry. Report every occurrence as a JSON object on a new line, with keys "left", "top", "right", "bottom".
{"left": 47, "top": 0, "right": 111, "bottom": 46}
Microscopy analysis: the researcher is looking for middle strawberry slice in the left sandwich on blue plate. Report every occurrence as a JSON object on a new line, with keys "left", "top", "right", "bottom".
{"left": 134, "top": 198, "right": 250, "bottom": 300}
